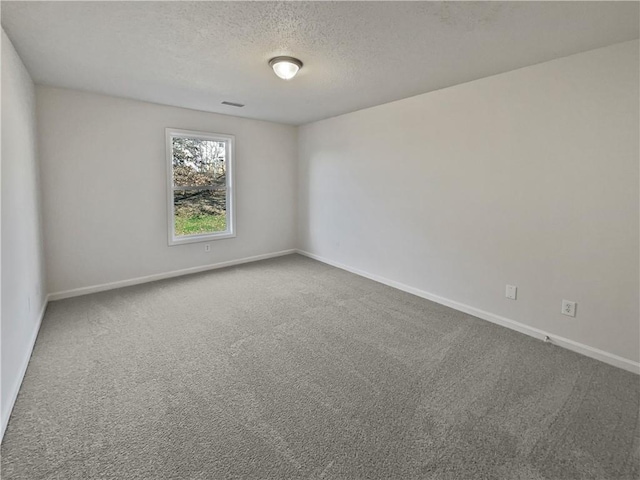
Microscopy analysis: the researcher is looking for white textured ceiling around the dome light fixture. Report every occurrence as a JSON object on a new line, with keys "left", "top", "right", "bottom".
{"left": 1, "top": 1, "right": 639, "bottom": 124}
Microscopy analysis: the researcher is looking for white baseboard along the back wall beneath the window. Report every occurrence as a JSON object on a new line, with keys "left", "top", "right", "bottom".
{"left": 49, "top": 248, "right": 297, "bottom": 301}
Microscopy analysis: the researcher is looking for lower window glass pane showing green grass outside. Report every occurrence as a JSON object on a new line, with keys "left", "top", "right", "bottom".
{"left": 173, "top": 190, "right": 227, "bottom": 236}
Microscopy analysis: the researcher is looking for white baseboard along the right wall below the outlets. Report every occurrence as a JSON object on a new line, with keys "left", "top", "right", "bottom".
{"left": 297, "top": 250, "right": 640, "bottom": 375}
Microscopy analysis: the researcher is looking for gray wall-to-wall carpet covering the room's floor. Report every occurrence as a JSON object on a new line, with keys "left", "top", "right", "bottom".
{"left": 2, "top": 255, "right": 640, "bottom": 480}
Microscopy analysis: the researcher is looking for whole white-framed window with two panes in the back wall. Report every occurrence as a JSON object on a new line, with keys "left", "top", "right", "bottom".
{"left": 166, "top": 128, "right": 235, "bottom": 245}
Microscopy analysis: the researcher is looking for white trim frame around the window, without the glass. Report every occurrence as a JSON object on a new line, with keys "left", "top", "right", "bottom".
{"left": 165, "top": 128, "right": 236, "bottom": 246}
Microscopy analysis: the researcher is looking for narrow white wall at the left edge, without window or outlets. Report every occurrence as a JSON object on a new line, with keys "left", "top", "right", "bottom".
{"left": 0, "top": 30, "right": 45, "bottom": 437}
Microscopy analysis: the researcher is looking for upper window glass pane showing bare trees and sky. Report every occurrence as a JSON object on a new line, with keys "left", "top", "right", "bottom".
{"left": 171, "top": 137, "right": 227, "bottom": 187}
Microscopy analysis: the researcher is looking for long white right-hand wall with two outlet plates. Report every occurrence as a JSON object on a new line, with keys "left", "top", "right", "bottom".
{"left": 299, "top": 41, "right": 640, "bottom": 362}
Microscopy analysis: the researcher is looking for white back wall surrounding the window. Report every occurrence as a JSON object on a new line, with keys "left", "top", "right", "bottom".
{"left": 36, "top": 86, "right": 297, "bottom": 293}
